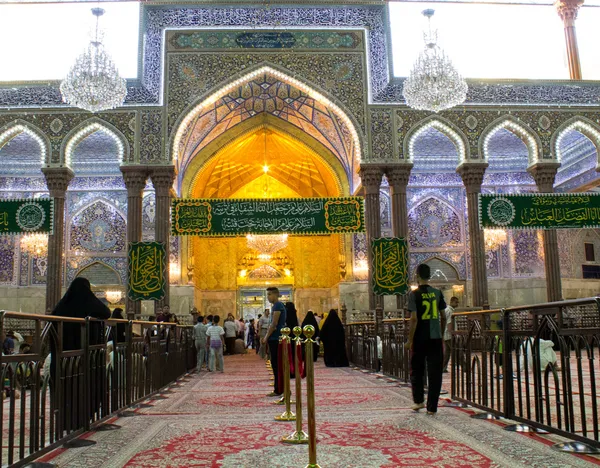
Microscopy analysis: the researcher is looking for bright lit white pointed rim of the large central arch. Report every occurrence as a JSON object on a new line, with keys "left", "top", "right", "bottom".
{"left": 167, "top": 64, "right": 366, "bottom": 188}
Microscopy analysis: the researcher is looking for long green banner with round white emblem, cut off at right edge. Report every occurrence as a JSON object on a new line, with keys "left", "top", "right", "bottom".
{"left": 479, "top": 193, "right": 600, "bottom": 229}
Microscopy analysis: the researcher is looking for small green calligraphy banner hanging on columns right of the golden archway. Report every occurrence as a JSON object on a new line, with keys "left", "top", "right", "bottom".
{"left": 371, "top": 237, "right": 409, "bottom": 296}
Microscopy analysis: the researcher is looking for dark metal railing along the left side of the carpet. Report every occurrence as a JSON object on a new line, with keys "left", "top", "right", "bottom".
{"left": 0, "top": 311, "right": 196, "bottom": 467}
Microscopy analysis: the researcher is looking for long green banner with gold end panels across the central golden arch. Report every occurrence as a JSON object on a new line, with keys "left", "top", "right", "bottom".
{"left": 171, "top": 197, "right": 365, "bottom": 237}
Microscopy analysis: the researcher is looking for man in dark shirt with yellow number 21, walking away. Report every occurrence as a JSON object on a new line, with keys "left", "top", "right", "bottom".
{"left": 406, "top": 264, "right": 446, "bottom": 416}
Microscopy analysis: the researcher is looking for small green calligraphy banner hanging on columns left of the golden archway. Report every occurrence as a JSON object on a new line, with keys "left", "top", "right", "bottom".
{"left": 127, "top": 242, "right": 167, "bottom": 301}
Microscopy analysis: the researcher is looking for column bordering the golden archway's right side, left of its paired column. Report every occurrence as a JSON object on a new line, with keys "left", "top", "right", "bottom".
{"left": 359, "top": 164, "right": 383, "bottom": 310}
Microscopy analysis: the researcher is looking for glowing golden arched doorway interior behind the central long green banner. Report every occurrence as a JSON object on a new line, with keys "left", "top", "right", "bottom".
{"left": 180, "top": 118, "right": 351, "bottom": 317}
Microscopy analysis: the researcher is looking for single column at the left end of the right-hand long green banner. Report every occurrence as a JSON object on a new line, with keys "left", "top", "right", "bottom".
{"left": 456, "top": 163, "right": 489, "bottom": 308}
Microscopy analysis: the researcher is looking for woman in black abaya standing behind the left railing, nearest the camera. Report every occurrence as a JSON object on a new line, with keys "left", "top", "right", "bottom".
{"left": 50, "top": 277, "right": 110, "bottom": 437}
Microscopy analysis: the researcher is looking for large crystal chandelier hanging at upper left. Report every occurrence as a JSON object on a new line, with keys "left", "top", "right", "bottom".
{"left": 60, "top": 8, "right": 127, "bottom": 112}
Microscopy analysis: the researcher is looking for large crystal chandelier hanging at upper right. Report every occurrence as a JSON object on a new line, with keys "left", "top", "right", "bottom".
{"left": 402, "top": 10, "right": 468, "bottom": 112}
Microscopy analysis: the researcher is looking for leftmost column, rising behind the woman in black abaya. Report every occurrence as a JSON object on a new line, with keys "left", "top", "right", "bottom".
{"left": 42, "top": 167, "right": 74, "bottom": 311}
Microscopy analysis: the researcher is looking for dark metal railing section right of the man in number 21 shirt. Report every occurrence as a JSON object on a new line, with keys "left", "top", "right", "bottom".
{"left": 451, "top": 298, "right": 600, "bottom": 447}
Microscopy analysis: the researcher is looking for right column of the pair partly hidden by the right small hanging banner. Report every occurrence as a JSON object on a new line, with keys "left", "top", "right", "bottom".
{"left": 385, "top": 163, "right": 413, "bottom": 309}
